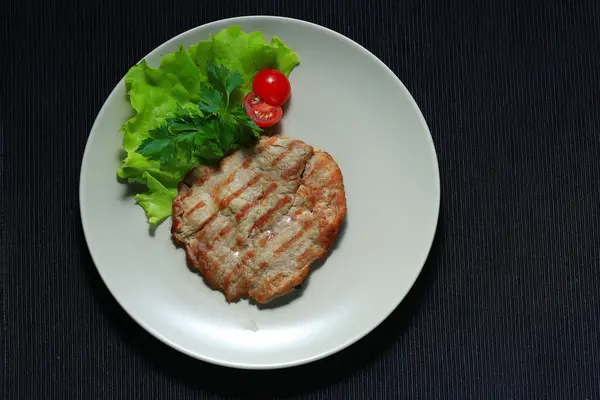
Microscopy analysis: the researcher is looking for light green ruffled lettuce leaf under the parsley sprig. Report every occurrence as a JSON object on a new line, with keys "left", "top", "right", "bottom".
{"left": 117, "top": 26, "right": 299, "bottom": 225}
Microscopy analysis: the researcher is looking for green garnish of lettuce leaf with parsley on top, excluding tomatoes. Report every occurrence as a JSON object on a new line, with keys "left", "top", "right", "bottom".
{"left": 117, "top": 26, "right": 299, "bottom": 227}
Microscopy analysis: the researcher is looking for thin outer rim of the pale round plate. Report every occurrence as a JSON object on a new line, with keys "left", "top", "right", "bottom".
{"left": 78, "top": 15, "right": 441, "bottom": 370}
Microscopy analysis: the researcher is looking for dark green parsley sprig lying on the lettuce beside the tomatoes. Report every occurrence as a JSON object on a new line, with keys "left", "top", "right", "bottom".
{"left": 136, "top": 62, "right": 261, "bottom": 164}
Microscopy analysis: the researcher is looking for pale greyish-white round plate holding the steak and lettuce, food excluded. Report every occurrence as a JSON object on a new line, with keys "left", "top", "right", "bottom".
{"left": 80, "top": 16, "right": 440, "bottom": 369}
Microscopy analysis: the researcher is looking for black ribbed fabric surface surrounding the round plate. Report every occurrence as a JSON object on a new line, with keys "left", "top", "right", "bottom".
{"left": 0, "top": 0, "right": 600, "bottom": 400}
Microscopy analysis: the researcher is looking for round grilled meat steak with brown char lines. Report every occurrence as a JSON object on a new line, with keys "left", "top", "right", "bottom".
{"left": 171, "top": 137, "right": 346, "bottom": 303}
